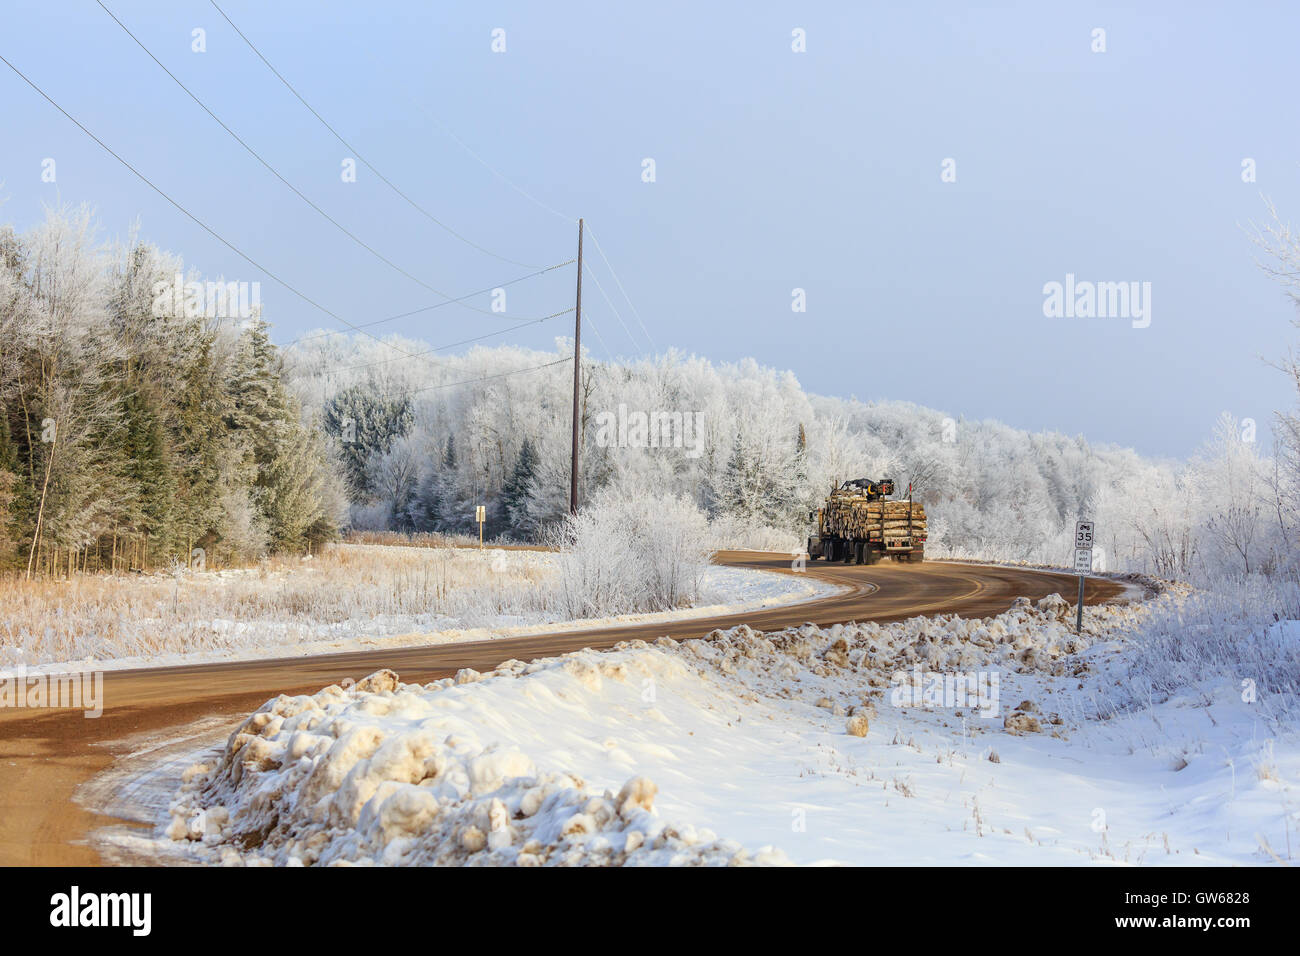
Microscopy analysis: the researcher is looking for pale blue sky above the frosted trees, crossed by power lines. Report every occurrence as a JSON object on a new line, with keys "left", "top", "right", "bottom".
{"left": 0, "top": 0, "right": 1300, "bottom": 455}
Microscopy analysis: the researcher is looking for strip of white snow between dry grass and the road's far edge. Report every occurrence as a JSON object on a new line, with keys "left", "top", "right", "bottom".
{"left": 20, "top": 546, "right": 840, "bottom": 674}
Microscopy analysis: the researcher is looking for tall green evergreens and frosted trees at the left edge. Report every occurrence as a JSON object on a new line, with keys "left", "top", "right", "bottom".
{"left": 0, "top": 208, "right": 346, "bottom": 574}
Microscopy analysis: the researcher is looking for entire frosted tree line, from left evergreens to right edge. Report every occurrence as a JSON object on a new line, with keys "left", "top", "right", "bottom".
{"left": 0, "top": 202, "right": 1300, "bottom": 579}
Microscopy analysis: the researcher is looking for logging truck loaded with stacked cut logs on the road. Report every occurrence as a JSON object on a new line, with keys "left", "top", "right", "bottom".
{"left": 807, "top": 479, "right": 926, "bottom": 564}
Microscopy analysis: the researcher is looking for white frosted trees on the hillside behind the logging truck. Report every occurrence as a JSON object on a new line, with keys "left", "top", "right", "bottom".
{"left": 289, "top": 334, "right": 1295, "bottom": 576}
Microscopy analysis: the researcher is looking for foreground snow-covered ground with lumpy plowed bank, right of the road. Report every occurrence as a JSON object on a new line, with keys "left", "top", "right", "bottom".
{"left": 142, "top": 591, "right": 1300, "bottom": 865}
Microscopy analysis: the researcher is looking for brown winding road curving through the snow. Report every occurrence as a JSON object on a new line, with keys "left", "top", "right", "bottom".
{"left": 0, "top": 551, "right": 1122, "bottom": 865}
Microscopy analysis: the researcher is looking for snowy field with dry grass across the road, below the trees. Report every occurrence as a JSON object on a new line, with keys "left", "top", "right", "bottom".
{"left": 10, "top": 545, "right": 836, "bottom": 674}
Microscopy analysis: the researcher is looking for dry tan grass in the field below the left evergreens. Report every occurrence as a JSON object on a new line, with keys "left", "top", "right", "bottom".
{"left": 0, "top": 545, "right": 554, "bottom": 666}
